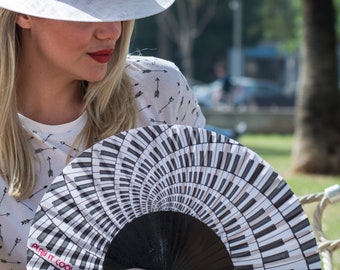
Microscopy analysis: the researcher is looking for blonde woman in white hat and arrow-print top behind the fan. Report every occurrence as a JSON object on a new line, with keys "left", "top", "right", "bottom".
{"left": 0, "top": 0, "right": 205, "bottom": 270}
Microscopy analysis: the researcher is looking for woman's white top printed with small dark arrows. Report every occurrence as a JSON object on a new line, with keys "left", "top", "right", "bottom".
{"left": 0, "top": 56, "right": 205, "bottom": 270}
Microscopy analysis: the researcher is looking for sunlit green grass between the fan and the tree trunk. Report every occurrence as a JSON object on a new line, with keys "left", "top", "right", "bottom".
{"left": 239, "top": 134, "right": 340, "bottom": 270}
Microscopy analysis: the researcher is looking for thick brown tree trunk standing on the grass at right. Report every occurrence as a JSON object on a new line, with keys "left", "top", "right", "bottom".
{"left": 293, "top": 0, "right": 340, "bottom": 174}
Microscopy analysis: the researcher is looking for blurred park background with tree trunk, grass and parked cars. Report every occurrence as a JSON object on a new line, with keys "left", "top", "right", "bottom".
{"left": 130, "top": 0, "right": 340, "bottom": 269}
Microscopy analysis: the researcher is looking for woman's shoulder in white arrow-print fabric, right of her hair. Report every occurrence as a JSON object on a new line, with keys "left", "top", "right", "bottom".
{"left": 127, "top": 56, "right": 204, "bottom": 126}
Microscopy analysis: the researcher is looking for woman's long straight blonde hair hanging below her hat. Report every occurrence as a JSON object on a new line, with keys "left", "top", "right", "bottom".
{"left": 0, "top": 8, "right": 137, "bottom": 200}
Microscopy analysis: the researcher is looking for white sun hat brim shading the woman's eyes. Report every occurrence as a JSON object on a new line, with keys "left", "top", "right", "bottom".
{"left": 0, "top": 0, "right": 175, "bottom": 22}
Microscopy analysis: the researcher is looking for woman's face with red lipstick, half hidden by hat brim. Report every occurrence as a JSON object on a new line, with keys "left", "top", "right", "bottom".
{"left": 17, "top": 14, "right": 122, "bottom": 82}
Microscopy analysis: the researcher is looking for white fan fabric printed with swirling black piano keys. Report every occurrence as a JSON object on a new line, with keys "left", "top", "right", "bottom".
{"left": 27, "top": 125, "right": 321, "bottom": 270}
